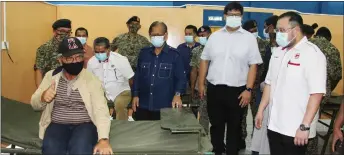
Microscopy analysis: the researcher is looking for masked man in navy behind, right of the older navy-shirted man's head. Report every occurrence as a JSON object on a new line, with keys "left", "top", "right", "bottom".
{"left": 177, "top": 25, "right": 201, "bottom": 85}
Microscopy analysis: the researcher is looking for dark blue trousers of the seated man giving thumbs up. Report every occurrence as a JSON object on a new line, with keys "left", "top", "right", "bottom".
{"left": 42, "top": 123, "right": 98, "bottom": 155}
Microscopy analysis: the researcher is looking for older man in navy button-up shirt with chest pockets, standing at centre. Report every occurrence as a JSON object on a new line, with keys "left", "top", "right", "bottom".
{"left": 132, "top": 21, "right": 186, "bottom": 120}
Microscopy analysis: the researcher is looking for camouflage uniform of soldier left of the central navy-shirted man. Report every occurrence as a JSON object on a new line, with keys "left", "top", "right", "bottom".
{"left": 111, "top": 33, "right": 151, "bottom": 69}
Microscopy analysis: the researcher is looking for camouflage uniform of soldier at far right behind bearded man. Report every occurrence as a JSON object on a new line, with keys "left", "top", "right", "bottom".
{"left": 306, "top": 36, "right": 342, "bottom": 155}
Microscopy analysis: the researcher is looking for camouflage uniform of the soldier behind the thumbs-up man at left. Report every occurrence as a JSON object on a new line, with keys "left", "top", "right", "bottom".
{"left": 36, "top": 38, "right": 60, "bottom": 76}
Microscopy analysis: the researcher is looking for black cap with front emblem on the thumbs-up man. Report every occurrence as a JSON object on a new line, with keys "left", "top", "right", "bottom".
{"left": 58, "top": 37, "right": 84, "bottom": 57}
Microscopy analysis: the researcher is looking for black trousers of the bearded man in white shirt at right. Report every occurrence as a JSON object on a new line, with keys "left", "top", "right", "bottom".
{"left": 268, "top": 130, "right": 307, "bottom": 155}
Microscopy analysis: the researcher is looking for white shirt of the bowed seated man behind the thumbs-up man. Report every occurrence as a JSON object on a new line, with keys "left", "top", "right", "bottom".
{"left": 87, "top": 52, "right": 134, "bottom": 101}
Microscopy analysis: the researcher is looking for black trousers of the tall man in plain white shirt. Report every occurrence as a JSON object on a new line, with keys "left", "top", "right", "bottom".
{"left": 207, "top": 83, "right": 245, "bottom": 155}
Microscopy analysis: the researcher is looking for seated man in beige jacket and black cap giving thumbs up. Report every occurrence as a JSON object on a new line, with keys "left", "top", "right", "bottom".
{"left": 31, "top": 37, "right": 112, "bottom": 154}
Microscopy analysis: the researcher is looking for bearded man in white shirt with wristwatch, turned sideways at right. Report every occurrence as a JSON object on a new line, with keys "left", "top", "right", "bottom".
{"left": 256, "top": 12, "right": 326, "bottom": 155}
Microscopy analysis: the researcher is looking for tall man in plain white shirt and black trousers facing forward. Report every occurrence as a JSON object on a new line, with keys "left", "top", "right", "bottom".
{"left": 199, "top": 2, "right": 262, "bottom": 155}
